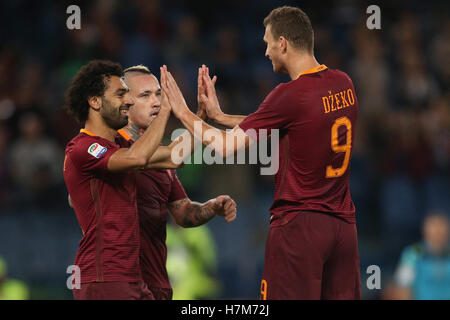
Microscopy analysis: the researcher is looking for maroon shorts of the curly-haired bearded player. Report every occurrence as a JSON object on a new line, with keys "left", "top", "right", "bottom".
{"left": 72, "top": 280, "right": 155, "bottom": 300}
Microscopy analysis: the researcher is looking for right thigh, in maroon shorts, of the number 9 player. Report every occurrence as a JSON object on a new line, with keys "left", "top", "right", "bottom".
{"left": 322, "top": 219, "right": 361, "bottom": 300}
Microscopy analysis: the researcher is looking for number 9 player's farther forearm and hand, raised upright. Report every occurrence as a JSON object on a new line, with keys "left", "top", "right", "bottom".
{"left": 198, "top": 65, "right": 246, "bottom": 129}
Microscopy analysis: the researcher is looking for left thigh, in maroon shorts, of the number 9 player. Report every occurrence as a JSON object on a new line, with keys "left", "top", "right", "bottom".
{"left": 261, "top": 213, "right": 335, "bottom": 300}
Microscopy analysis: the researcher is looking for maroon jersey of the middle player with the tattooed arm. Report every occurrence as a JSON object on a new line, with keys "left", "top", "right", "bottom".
{"left": 116, "top": 130, "right": 187, "bottom": 288}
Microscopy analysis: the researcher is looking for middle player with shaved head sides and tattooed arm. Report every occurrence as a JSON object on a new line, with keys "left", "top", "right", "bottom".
{"left": 117, "top": 66, "right": 236, "bottom": 300}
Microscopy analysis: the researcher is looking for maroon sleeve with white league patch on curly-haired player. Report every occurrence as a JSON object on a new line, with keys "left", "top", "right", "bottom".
{"left": 68, "top": 137, "right": 119, "bottom": 172}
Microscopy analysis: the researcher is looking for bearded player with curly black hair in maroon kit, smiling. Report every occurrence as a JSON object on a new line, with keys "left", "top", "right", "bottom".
{"left": 64, "top": 60, "right": 171, "bottom": 300}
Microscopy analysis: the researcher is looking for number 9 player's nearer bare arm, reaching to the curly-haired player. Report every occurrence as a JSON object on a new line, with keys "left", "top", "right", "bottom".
{"left": 161, "top": 66, "right": 253, "bottom": 157}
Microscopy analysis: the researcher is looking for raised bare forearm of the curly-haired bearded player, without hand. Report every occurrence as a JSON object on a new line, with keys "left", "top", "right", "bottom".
{"left": 129, "top": 108, "right": 170, "bottom": 165}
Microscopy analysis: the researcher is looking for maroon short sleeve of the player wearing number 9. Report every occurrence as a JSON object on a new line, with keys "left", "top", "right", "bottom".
{"left": 239, "top": 83, "right": 298, "bottom": 140}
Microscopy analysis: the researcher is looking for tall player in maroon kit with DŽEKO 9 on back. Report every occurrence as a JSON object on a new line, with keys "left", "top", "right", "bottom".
{"left": 162, "top": 6, "right": 361, "bottom": 299}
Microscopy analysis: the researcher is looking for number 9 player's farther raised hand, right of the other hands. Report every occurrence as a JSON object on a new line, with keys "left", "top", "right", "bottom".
{"left": 199, "top": 65, "right": 223, "bottom": 121}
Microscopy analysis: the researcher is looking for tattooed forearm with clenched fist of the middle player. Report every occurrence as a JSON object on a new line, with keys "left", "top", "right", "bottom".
{"left": 168, "top": 195, "right": 236, "bottom": 228}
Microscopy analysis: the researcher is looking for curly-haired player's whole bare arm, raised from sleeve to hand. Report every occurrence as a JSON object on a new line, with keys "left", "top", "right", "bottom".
{"left": 108, "top": 69, "right": 171, "bottom": 171}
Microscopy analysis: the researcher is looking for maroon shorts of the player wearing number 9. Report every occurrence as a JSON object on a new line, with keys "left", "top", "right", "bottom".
{"left": 261, "top": 212, "right": 361, "bottom": 300}
